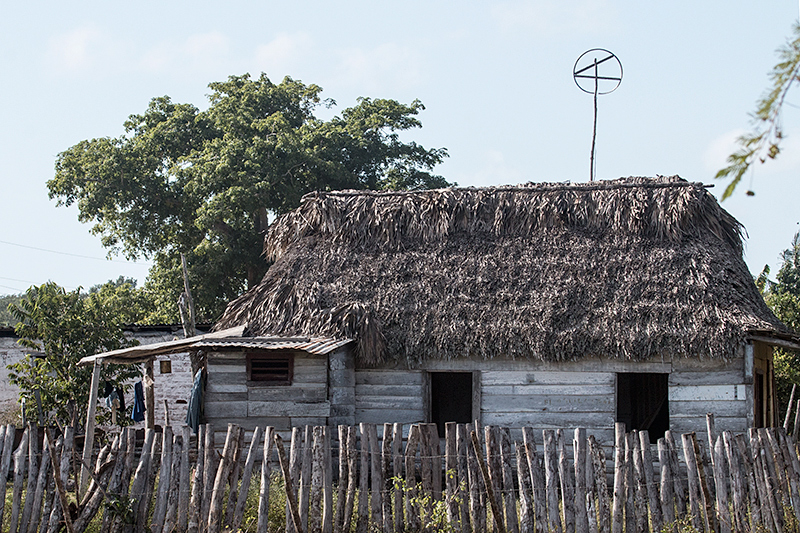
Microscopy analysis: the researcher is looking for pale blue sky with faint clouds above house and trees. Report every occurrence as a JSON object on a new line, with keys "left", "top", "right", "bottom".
{"left": 0, "top": 0, "right": 800, "bottom": 294}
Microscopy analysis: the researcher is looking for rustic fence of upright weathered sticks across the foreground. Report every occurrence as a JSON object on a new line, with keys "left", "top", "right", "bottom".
{"left": 0, "top": 417, "right": 800, "bottom": 533}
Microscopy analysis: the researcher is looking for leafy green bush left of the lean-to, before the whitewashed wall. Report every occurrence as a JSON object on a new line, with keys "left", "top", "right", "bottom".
{"left": 8, "top": 282, "right": 140, "bottom": 424}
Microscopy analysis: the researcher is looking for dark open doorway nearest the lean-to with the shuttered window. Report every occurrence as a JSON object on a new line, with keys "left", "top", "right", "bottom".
{"left": 430, "top": 372, "right": 472, "bottom": 437}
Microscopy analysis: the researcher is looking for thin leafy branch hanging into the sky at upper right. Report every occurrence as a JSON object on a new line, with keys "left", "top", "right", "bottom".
{"left": 715, "top": 24, "right": 800, "bottom": 200}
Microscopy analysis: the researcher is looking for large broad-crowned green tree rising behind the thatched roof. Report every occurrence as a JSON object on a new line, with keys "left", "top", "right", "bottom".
{"left": 47, "top": 74, "right": 449, "bottom": 320}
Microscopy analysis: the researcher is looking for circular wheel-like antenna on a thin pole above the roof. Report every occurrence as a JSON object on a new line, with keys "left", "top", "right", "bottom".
{"left": 572, "top": 48, "right": 622, "bottom": 181}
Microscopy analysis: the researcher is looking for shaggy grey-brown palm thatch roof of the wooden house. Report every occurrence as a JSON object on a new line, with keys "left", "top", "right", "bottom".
{"left": 217, "top": 176, "right": 786, "bottom": 365}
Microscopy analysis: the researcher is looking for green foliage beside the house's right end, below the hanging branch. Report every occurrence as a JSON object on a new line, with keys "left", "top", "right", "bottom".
{"left": 758, "top": 233, "right": 800, "bottom": 420}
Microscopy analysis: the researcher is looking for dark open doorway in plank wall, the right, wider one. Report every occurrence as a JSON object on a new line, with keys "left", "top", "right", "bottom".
{"left": 617, "top": 373, "right": 669, "bottom": 444}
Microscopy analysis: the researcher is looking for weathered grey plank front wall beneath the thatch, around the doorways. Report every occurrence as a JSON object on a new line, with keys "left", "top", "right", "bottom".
{"left": 206, "top": 353, "right": 752, "bottom": 446}
